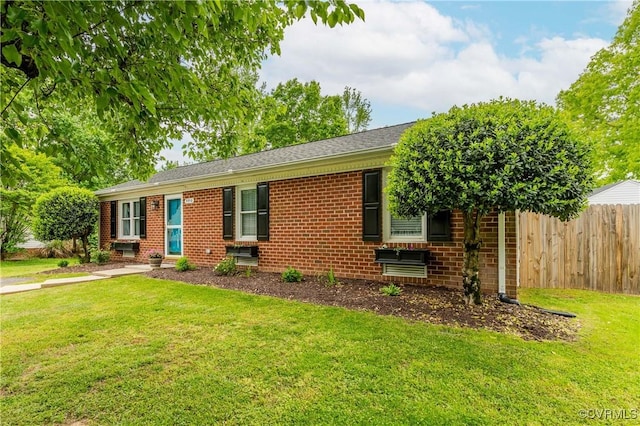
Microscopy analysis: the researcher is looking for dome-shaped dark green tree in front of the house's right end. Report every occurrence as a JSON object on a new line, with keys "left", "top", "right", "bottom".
{"left": 388, "top": 98, "right": 592, "bottom": 304}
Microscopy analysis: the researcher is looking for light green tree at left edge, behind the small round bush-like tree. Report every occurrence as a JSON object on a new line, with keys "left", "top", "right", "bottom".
{"left": 0, "top": 144, "right": 66, "bottom": 259}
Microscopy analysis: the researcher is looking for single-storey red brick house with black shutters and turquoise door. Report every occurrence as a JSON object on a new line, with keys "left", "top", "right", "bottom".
{"left": 96, "top": 123, "right": 517, "bottom": 297}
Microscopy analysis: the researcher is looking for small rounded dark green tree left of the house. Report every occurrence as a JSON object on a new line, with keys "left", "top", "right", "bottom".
{"left": 33, "top": 187, "right": 99, "bottom": 262}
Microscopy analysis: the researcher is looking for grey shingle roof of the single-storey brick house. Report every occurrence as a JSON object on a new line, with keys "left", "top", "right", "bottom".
{"left": 96, "top": 122, "right": 415, "bottom": 194}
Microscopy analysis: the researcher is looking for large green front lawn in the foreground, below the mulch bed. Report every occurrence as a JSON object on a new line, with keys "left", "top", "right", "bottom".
{"left": 0, "top": 276, "right": 640, "bottom": 425}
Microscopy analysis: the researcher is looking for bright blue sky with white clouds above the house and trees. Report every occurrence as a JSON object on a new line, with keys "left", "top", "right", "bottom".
{"left": 163, "top": 0, "right": 631, "bottom": 161}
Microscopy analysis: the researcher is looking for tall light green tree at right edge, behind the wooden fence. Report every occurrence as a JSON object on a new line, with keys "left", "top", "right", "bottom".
{"left": 557, "top": 0, "right": 640, "bottom": 183}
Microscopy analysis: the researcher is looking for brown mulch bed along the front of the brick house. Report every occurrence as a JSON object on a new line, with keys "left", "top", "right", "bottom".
{"left": 147, "top": 268, "right": 580, "bottom": 341}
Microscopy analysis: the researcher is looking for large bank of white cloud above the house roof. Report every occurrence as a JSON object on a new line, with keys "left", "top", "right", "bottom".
{"left": 262, "top": 2, "right": 607, "bottom": 125}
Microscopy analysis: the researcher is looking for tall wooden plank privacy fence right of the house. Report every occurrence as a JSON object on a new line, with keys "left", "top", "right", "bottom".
{"left": 519, "top": 204, "right": 640, "bottom": 294}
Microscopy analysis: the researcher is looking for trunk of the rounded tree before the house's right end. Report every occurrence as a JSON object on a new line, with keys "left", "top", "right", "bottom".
{"left": 462, "top": 211, "right": 482, "bottom": 305}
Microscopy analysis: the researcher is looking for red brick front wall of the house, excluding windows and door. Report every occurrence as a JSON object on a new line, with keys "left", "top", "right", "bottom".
{"left": 101, "top": 172, "right": 517, "bottom": 297}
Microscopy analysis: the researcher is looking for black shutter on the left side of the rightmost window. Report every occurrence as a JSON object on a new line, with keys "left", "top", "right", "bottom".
{"left": 362, "top": 170, "right": 382, "bottom": 241}
